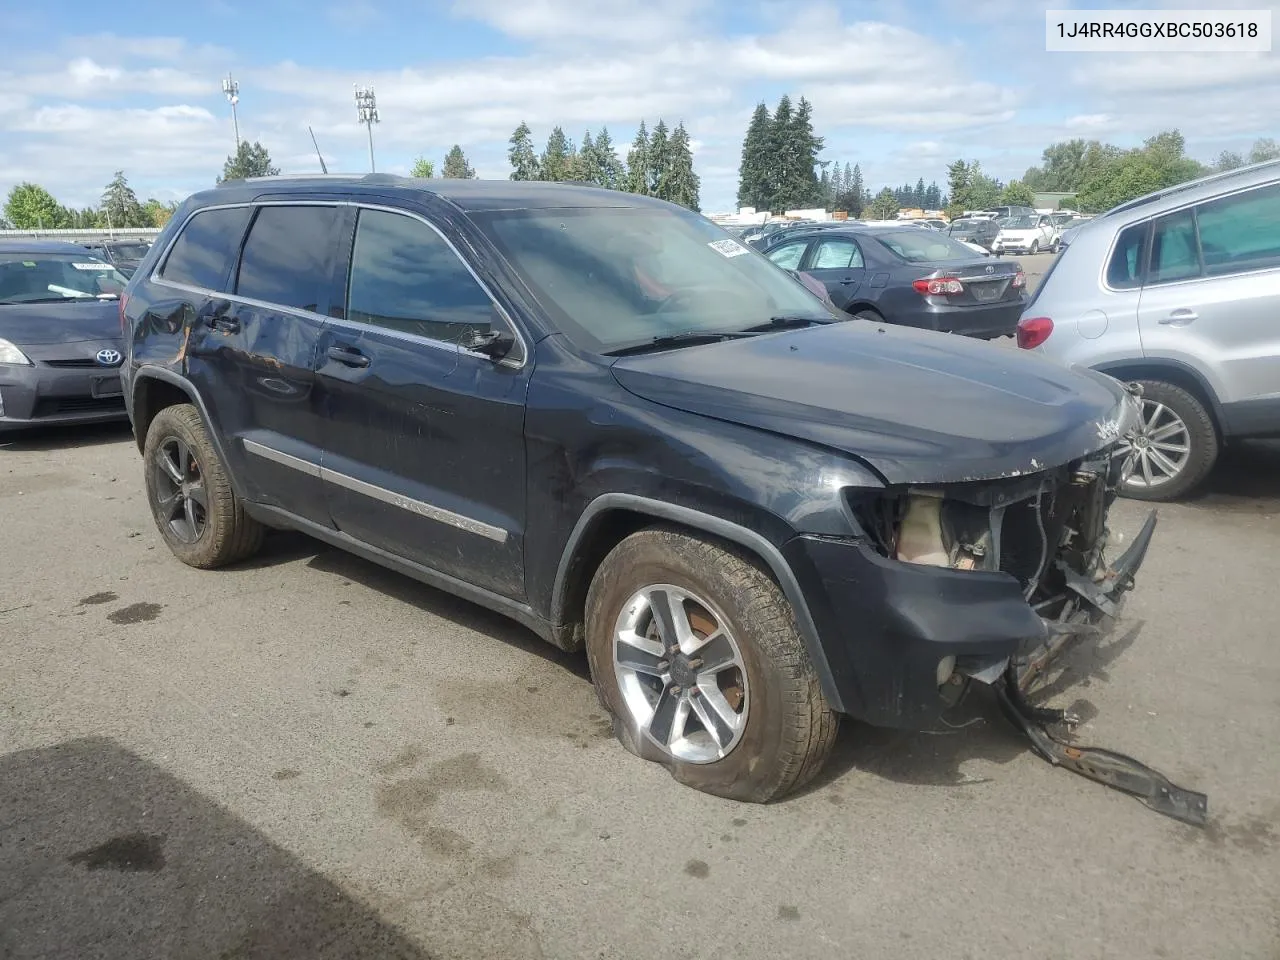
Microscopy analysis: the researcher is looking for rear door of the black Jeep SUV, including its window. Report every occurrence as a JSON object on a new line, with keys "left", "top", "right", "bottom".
{"left": 187, "top": 202, "right": 343, "bottom": 526}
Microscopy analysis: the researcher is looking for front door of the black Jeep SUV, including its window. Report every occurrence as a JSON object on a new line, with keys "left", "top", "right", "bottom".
{"left": 317, "top": 209, "right": 531, "bottom": 599}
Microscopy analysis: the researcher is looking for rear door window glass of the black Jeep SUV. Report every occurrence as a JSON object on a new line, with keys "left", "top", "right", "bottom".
{"left": 236, "top": 206, "right": 338, "bottom": 312}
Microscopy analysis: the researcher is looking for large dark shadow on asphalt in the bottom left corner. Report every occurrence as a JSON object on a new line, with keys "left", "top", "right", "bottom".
{"left": 0, "top": 737, "right": 428, "bottom": 960}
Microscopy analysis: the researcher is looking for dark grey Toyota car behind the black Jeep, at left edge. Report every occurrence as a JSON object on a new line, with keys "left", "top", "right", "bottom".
{"left": 0, "top": 239, "right": 125, "bottom": 434}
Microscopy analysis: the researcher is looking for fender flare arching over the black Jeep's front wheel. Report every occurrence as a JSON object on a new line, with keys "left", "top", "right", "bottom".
{"left": 552, "top": 493, "right": 845, "bottom": 713}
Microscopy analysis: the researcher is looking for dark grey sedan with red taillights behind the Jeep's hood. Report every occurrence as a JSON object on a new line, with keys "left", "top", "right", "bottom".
{"left": 765, "top": 223, "right": 1027, "bottom": 338}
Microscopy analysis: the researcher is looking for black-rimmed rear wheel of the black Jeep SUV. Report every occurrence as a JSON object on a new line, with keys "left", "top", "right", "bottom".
{"left": 142, "top": 403, "right": 265, "bottom": 570}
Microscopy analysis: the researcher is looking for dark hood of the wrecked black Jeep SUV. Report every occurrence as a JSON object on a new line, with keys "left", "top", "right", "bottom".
{"left": 612, "top": 320, "right": 1132, "bottom": 484}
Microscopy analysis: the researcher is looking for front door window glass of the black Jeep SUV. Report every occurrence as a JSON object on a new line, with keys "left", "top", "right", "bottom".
{"left": 347, "top": 210, "right": 494, "bottom": 343}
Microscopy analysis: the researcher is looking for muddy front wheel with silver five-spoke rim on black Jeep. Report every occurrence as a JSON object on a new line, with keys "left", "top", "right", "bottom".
{"left": 586, "top": 530, "right": 840, "bottom": 803}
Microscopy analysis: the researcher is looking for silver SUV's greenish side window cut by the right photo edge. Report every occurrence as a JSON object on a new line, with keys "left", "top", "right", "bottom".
{"left": 1196, "top": 183, "right": 1280, "bottom": 276}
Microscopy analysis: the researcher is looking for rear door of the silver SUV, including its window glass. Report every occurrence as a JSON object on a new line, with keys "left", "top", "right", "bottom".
{"left": 1138, "top": 183, "right": 1280, "bottom": 422}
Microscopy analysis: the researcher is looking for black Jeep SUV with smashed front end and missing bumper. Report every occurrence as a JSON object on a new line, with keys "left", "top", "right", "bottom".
{"left": 122, "top": 174, "right": 1153, "bottom": 801}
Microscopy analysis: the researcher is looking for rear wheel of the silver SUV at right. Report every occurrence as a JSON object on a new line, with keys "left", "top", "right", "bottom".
{"left": 1120, "top": 380, "right": 1220, "bottom": 502}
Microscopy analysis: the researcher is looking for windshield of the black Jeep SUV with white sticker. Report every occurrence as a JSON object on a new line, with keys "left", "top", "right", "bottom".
{"left": 474, "top": 207, "right": 833, "bottom": 353}
